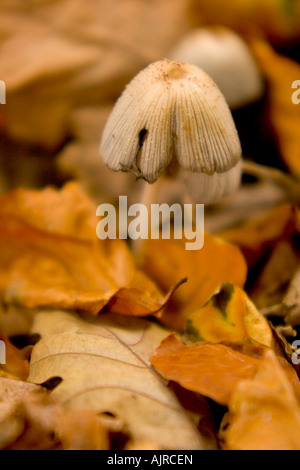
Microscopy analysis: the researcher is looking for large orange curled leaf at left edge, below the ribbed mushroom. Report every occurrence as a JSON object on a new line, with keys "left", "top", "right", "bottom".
{"left": 0, "top": 183, "right": 169, "bottom": 315}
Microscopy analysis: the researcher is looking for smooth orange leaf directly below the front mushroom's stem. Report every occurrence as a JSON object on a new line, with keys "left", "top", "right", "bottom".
{"left": 141, "top": 233, "right": 247, "bottom": 329}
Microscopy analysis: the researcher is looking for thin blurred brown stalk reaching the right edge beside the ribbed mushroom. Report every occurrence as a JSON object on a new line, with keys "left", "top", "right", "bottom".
{"left": 243, "top": 161, "right": 300, "bottom": 204}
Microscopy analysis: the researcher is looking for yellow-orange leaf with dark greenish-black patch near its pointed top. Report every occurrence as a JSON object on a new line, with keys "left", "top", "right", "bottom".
{"left": 185, "top": 283, "right": 274, "bottom": 347}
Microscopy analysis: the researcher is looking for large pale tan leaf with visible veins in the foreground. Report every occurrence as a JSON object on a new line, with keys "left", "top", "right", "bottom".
{"left": 28, "top": 311, "right": 203, "bottom": 449}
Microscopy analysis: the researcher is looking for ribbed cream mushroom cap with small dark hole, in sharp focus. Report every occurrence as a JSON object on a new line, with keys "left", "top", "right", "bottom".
{"left": 100, "top": 59, "right": 241, "bottom": 203}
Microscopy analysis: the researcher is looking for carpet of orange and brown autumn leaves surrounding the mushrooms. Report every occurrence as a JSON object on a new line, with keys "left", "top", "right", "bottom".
{"left": 0, "top": 0, "right": 300, "bottom": 450}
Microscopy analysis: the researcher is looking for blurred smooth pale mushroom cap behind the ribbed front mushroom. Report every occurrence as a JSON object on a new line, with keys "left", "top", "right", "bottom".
{"left": 170, "top": 27, "right": 264, "bottom": 109}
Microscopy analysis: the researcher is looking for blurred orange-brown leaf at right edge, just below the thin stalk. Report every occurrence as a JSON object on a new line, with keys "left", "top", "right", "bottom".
{"left": 219, "top": 204, "right": 300, "bottom": 309}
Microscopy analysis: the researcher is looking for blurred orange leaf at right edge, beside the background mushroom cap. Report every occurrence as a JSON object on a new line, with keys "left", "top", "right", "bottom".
{"left": 252, "top": 40, "right": 300, "bottom": 177}
